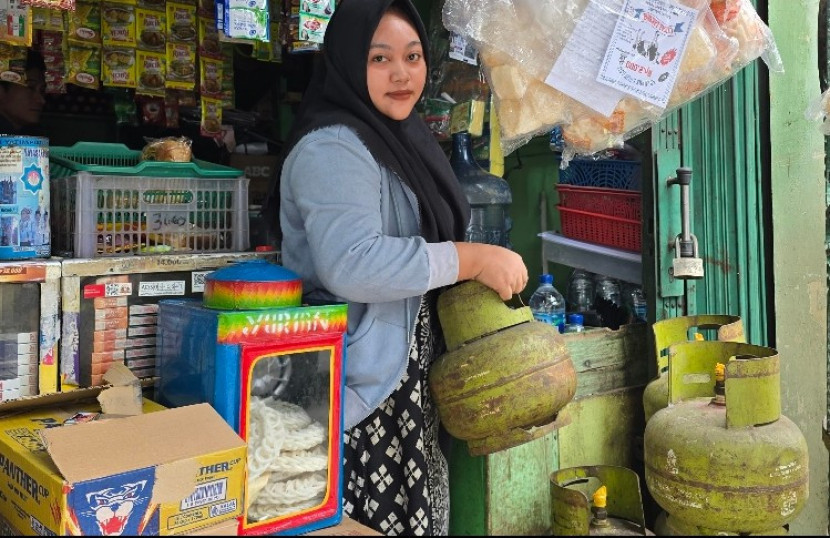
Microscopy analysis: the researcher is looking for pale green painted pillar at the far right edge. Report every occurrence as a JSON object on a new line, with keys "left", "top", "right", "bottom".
{"left": 768, "top": 0, "right": 828, "bottom": 535}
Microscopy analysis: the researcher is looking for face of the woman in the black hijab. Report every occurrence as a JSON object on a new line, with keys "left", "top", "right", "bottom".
{"left": 366, "top": 11, "right": 427, "bottom": 121}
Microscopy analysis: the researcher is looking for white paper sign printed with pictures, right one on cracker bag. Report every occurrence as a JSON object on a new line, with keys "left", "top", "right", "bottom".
{"left": 597, "top": 0, "right": 698, "bottom": 108}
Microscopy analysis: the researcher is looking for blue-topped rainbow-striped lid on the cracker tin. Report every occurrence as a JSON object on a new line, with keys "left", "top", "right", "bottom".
{"left": 202, "top": 260, "right": 303, "bottom": 310}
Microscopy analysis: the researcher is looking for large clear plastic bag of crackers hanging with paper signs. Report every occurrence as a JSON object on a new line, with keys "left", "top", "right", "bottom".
{"left": 442, "top": 0, "right": 783, "bottom": 163}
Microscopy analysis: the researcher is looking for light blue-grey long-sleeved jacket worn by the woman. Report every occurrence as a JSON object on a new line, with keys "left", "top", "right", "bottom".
{"left": 280, "top": 125, "right": 458, "bottom": 428}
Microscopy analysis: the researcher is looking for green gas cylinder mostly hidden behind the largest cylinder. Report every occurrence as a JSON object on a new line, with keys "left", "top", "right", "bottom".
{"left": 643, "top": 314, "right": 746, "bottom": 422}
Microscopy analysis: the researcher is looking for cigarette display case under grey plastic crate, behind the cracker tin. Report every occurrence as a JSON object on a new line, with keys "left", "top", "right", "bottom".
{"left": 60, "top": 252, "right": 274, "bottom": 387}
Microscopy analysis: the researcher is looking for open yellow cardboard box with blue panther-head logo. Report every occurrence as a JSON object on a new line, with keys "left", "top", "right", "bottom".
{"left": 0, "top": 365, "right": 246, "bottom": 536}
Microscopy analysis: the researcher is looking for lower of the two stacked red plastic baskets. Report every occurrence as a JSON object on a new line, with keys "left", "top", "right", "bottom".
{"left": 556, "top": 204, "right": 643, "bottom": 252}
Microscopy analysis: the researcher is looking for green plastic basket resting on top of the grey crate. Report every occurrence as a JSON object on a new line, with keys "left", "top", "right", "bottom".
{"left": 49, "top": 142, "right": 245, "bottom": 178}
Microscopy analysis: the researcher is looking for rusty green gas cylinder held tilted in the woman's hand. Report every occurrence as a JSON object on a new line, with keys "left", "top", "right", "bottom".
{"left": 429, "top": 281, "right": 576, "bottom": 456}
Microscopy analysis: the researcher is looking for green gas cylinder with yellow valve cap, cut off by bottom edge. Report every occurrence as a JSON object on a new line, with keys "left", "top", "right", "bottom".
{"left": 550, "top": 465, "right": 654, "bottom": 536}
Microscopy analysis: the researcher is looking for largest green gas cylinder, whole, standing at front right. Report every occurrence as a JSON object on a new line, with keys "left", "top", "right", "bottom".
{"left": 645, "top": 341, "right": 809, "bottom": 534}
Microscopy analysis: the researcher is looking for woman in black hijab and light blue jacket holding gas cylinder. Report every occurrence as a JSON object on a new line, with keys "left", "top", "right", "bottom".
{"left": 280, "top": 0, "right": 527, "bottom": 535}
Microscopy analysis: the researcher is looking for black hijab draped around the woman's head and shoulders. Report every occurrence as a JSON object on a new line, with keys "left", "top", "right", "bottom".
{"left": 272, "top": 0, "right": 470, "bottom": 242}
